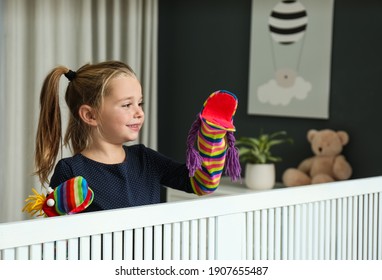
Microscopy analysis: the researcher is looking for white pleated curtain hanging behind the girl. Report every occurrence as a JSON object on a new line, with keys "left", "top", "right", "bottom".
{"left": 0, "top": 0, "right": 158, "bottom": 222}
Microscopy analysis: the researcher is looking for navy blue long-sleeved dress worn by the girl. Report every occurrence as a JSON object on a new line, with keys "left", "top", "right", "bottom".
{"left": 50, "top": 144, "right": 194, "bottom": 212}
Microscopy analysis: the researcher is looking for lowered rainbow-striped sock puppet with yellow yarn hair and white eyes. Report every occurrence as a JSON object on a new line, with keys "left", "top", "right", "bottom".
{"left": 23, "top": 176, "right": 94, "bottom": 217}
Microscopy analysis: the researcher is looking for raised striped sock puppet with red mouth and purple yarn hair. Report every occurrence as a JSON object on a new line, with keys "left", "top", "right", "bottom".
{"left": 187, "top": 90, "right": 241, "bottom": 195}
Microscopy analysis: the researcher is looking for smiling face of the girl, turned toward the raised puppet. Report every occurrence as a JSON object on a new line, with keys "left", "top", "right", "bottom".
{"left": 99, "top": 76, "right": 145, "bottom": 145}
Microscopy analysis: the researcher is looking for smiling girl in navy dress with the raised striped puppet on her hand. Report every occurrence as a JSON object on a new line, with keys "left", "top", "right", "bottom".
{"left": 29, "top": 61, "right": 240, "bottom": 216}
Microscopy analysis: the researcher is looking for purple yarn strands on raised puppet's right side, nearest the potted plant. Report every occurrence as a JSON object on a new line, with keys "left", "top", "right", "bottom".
{"left": 225, "top": 131, "right": 241, "bottom": 181}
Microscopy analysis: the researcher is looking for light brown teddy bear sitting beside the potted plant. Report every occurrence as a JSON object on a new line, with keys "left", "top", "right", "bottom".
{"left": 282, "top": 129, "right": 352, "bottom": 187}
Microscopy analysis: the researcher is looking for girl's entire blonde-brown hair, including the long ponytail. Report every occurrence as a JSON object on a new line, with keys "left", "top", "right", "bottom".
{"left": 35, "top": 61, "right": 136, "bottom": 184}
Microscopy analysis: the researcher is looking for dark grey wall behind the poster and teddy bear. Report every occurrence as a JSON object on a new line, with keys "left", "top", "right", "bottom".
{"left": 158, "top": 0, "right": 382, "bottom": 183}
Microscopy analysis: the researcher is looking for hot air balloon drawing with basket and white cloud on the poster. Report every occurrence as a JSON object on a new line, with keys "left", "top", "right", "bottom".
{"left": 257, "top": 0, "right": 312, "bottom": 106}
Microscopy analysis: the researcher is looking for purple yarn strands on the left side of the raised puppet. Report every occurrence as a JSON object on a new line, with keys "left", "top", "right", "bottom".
{"left": 186, "top": 114, "right": 203, "bottom": 177}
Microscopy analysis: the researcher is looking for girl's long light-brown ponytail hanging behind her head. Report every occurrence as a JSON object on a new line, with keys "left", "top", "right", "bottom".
{"left": 35, "top": 67, "right": 68, "bottom": 184}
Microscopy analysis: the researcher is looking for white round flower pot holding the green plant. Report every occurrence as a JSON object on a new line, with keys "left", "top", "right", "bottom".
{"left": 245, "top": 163, "right": 276, "bottom": 190}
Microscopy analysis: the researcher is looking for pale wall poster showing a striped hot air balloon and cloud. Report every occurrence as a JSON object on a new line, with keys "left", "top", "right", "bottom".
{"left": 248, "top": 0, "right": 334, "bottom": 119}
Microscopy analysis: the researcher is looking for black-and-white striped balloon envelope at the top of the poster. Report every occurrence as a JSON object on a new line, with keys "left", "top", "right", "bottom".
{"left": 268, "top": 0, "right": 308, "bottom": 45}
